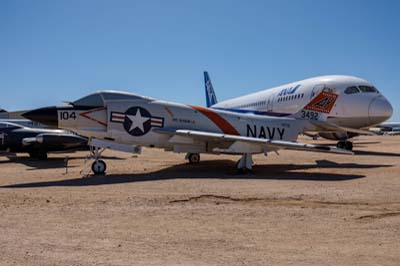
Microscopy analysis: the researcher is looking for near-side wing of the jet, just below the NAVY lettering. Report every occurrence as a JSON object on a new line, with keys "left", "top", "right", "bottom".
{"left": 156, "top": 129, "right": 353, "bottom": 155}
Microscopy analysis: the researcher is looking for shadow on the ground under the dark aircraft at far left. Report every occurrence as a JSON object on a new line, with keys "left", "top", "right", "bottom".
{"left": 0, "top": 156, "right": 125, "bottom": 171}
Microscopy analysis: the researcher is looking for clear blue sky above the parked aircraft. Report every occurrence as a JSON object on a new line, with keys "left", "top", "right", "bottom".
{"left": 0, "top": 0, "right": 400, "bottom": 120}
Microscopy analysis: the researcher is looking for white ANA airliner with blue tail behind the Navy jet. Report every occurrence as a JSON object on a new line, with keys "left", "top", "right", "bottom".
{"left": 204, "top": 72, "right": 393, "bottom": 150}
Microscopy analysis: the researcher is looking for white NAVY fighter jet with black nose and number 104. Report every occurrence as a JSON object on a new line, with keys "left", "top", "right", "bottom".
{"left": 23, "top": 91, "right": 360, "bottom": 174}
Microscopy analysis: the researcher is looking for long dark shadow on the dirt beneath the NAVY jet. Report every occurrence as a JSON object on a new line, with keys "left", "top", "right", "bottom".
{"left": 2, "top": 160, "right": 392, "bottom": 188}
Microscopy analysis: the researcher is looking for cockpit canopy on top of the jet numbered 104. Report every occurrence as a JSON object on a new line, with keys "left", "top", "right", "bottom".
{"left": 71, "top": 91, "right": 152, "bottom": 107}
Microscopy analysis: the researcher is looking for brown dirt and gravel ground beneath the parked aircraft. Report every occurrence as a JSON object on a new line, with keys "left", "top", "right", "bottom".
{"left": 0, "top": 136, "right": 400, "bottom": 266}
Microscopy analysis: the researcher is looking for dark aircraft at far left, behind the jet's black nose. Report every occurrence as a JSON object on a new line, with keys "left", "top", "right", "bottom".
{"left": 0, "top": 122, "right": 87, "bottom": 160}
